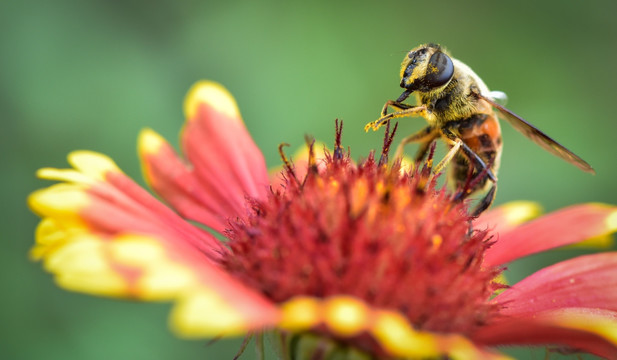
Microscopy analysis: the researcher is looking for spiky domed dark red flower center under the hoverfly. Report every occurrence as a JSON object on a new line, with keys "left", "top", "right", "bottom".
{"left": 224, "top": 124, "right": 500, "bottom": 333}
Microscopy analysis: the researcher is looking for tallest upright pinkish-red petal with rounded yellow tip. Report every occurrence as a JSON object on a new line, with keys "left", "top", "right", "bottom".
{"left": 181, "top": 82, "right": 269, "bottom": 208}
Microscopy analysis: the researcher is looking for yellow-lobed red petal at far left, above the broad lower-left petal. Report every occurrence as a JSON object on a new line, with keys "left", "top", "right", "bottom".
{"left": 29, "top": 151, "right": 228, "bottom": 261}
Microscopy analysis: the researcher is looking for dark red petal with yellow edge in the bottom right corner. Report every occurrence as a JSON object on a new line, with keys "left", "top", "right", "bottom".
{"left": 472, "top": 308, "right": 617, "bottom": 360}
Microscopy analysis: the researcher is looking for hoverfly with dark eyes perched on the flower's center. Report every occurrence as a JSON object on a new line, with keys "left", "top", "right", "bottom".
{"left": 365, "top": 44, "right": 595, "bottom": 216}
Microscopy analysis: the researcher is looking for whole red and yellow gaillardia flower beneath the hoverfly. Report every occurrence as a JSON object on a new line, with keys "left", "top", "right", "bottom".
{"left": 29, "top": 82, "right": 617, "bottom": 359}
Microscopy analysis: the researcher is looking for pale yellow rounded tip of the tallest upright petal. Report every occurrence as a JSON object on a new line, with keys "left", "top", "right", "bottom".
{"left": 184, "top": 80, "right": 240, "bottom": 121}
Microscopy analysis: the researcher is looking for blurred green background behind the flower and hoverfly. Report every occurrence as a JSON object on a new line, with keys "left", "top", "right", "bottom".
{"left": 0, "top": 0, "right": 617, "bottom": 359}
